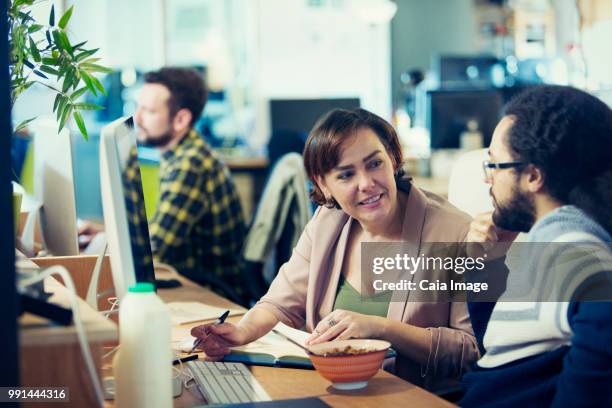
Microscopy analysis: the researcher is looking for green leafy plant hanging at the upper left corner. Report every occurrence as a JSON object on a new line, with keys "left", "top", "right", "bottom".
{"left": 8, "top": 0, "right": 111, "bottom": 139}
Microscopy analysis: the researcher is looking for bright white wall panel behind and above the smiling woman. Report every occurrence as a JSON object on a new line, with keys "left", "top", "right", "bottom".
{"left": 248, "top": 0, "right": 391, "bottom": 144}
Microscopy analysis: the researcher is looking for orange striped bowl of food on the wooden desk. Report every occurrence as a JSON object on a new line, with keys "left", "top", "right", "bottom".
{"left": 308, "top": 339, "right": 391, "bottom": 390}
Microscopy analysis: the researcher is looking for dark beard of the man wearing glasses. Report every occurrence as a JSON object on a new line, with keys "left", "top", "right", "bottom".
{"left": 491, "top": 186, "right": 535, "bottom": 232}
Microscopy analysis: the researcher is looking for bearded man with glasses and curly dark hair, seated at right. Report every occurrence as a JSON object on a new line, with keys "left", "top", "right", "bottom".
{"left": 460, "top": 86, "right": 612, "bottom": 407}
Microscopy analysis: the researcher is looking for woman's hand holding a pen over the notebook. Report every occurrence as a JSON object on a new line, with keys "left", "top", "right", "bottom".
{"left": 191, "top": 323, "right": 247, "bottom": 361}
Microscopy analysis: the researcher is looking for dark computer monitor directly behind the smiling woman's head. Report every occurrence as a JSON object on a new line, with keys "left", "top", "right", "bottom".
{"left": 270, "top": 98, "right": 360, "bottom": 134}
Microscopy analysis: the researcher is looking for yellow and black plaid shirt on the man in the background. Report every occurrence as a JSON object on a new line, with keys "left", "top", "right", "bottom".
{"left": 149, "top": 129, "right": 245, "bottom": 295}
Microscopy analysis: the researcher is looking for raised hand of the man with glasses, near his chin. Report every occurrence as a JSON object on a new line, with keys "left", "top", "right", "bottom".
{"left": 466, "top": 212, "right": 518, "bottom": 258}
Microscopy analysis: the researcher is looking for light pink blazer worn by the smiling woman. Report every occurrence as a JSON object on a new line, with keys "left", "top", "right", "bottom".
{"left": 254, "top": 186, "right": 479, "bottom": 389}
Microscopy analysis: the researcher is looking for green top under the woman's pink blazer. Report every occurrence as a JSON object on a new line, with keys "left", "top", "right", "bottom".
{"left": 334, "top": 274, "right": 392, "bottom": 317}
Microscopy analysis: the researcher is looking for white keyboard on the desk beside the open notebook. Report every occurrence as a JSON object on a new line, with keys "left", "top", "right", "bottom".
{"left": 186, "top": 360, "right": 271, "bottom": 404}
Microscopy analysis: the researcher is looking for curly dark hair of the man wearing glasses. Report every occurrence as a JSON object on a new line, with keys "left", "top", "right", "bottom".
{"left": 505, "top": 86, "right": 612, "bottom": 231}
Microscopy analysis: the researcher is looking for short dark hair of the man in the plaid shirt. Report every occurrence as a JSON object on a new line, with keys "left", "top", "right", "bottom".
{"left": 144, "top": 68, "right": 208, "bottom": 126}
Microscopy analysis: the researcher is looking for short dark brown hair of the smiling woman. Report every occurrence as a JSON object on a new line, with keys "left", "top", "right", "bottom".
{"left": 304, "top": 109, "right": 404, "bottom": 208}
